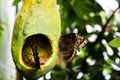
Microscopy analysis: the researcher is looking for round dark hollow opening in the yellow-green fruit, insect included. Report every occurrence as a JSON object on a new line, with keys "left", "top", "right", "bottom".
{"left": 22, "top": 34, "right": 52, "bottom": 68}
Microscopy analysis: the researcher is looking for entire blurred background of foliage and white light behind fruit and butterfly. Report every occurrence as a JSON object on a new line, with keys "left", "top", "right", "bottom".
{"left": 0, "top": 0, "right": 120, "bottom": 80}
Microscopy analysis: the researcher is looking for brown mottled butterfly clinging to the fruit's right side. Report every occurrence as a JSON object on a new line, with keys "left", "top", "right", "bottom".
{"left": 59, "top": 33, "right": 87, "bottom": 62}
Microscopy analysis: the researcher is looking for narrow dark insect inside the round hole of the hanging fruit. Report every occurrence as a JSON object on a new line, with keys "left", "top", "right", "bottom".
{"left": 28, "top": 37, "right": 40, "bottom": 69}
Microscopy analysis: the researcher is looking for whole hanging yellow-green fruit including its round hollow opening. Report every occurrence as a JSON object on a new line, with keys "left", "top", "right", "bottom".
{"left": 11, "top": 0, "right": 61, "bottom": 80}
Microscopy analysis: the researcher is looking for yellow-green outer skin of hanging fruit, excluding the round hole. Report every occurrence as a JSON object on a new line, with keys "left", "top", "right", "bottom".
{"left": 12, "top": 0, "right": 61, "bottom": 80}
